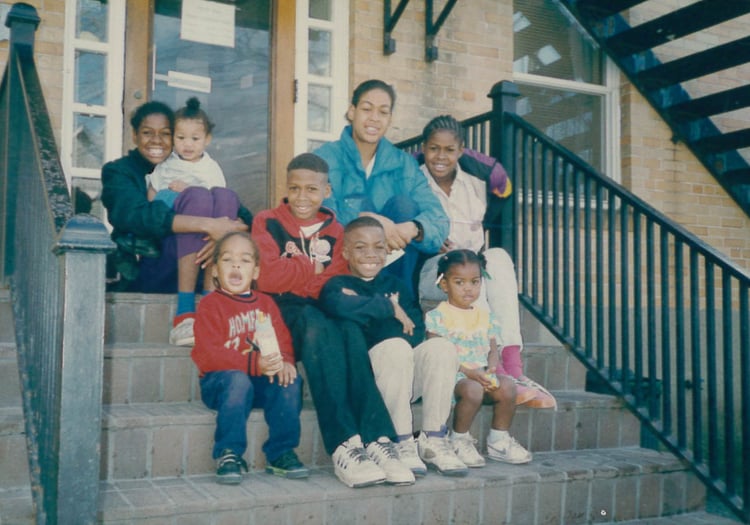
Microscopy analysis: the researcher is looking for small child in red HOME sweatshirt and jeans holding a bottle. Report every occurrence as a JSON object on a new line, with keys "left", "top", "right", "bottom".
{"left": 191, "top": 232, "right": 308, "bottom": 485}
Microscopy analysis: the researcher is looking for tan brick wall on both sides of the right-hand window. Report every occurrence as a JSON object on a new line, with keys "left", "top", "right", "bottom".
{"left": 350, "top": 0, "right": 750, "bottom": 271}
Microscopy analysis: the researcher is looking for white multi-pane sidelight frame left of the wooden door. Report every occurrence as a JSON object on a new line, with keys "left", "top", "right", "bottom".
{"left": 60, "top": 0, "right": 126, "bottom": 185}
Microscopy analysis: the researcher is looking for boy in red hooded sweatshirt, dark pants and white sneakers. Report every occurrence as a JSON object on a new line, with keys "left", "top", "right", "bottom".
{"left": 252, "top": 153, "right": 414, "bottom": 487}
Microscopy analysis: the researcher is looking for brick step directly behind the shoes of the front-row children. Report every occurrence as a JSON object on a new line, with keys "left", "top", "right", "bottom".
{"left": 102, "top": 392, "right": 639, "bottom": 480}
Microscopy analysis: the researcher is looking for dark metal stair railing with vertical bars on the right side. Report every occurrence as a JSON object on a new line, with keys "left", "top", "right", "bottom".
{"left": 399, "top": 82, "right": 750, "bottom": 521}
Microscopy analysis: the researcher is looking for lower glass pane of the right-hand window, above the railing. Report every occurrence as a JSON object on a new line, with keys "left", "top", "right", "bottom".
{"left": 517, "top": 85, "right": 604, "bottom": 172}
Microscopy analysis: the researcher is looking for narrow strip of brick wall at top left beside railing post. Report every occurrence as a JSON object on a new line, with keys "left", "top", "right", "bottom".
{"left": 0, "top": 0, "right": 65, "bottom": 143}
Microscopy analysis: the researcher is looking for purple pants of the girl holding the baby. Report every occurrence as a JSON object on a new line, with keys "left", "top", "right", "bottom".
{"left": 133, "top": 186, "right": 240, "bottom": 293}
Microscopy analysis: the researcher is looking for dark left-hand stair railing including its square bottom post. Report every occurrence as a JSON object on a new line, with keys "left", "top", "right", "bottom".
{"left": 0, "top": 3, "right": 113, "bottom": 524}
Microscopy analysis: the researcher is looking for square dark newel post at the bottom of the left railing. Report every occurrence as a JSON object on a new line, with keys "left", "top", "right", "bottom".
{"left": 54, "top": 215, "right": 114, "bottom": 525}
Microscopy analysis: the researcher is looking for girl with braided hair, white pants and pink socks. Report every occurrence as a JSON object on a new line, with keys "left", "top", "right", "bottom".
{"left": 418, "top": 115, "right": 557, "bottom": 408}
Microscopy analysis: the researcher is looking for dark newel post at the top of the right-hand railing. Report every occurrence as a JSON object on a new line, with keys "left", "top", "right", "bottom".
{"left": 487, "top": 80, "right": 521, "bottom": 255}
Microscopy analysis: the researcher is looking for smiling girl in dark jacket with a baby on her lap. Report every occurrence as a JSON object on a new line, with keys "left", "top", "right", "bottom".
{"left": 102, "top": 101, "right": 252, "bottom": 344}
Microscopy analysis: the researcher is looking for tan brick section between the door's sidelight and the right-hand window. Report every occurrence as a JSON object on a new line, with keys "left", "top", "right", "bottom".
{"left": 342, "top": 0, "right": 513, "bottom": 140}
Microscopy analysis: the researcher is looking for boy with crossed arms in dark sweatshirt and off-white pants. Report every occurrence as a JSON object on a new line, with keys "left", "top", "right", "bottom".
{"left": 320, "top": 216, "right": 469, "bottom": 476}
